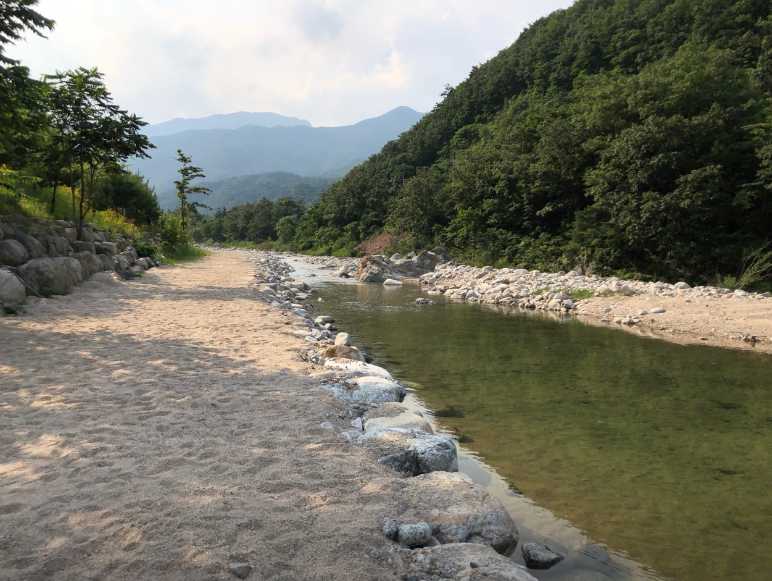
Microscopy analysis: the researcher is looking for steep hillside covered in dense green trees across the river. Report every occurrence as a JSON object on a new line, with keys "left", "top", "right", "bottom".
{"left": 295, "top": 0, "right": 772, "bottom": 280}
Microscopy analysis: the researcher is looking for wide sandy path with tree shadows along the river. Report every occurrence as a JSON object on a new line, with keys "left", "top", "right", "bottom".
{"left": 0, "top": 251, "right": 404, "bottom": 581}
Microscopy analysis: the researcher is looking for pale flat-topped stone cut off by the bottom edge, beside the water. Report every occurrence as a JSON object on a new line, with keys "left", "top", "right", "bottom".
{"left": 403, "top": 543, "right": 537, "bottom": 581}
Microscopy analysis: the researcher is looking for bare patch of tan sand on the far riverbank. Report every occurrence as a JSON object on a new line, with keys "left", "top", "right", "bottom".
{"left": 576, "top": 295, "right": 772, "bottom": 354}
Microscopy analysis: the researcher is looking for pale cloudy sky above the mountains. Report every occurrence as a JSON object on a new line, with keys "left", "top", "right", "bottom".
{"left": 7, "top": 0, "right": 572, "bottom": 125}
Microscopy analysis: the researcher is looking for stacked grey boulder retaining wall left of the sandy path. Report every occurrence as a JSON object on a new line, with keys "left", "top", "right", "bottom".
{"left": 0, "top": 217, "right": 157, "bottom": 314}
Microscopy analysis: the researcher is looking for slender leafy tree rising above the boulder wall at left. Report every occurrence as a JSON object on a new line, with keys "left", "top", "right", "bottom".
{"left": 49, "top": 67, "right": 153, "bottom": 236}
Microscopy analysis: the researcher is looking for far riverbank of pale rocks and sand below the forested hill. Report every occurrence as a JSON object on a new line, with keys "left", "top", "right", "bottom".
{"left": 296, "top": 254, "right": 772, "bottom": 353}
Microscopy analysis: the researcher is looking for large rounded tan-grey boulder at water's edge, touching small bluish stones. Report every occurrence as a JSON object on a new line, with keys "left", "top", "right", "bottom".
{"left": 396, "top": 472, "right": 519, "bottom": 555}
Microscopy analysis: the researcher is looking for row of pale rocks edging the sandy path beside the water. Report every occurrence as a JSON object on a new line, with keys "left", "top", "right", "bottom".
{"left": 250, "top": 253, "right": 535, "bottom": 581}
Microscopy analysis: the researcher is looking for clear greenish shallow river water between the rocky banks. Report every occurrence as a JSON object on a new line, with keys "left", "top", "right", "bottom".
{"left": 311, "top": 279, "right": 772, "bottom": 581}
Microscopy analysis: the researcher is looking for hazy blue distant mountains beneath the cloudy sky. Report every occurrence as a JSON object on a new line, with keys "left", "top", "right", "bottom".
{"left": 129, "top": 107, "right": 423, "bottom": 208}
